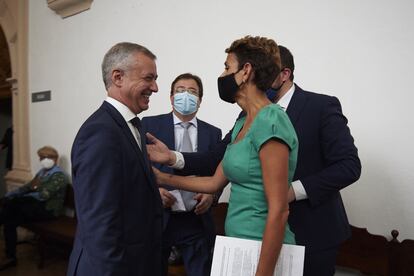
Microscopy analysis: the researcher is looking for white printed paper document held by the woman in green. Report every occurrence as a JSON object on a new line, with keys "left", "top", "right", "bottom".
{"left": 210, "top": 236, "right": 305, "bottom": 276}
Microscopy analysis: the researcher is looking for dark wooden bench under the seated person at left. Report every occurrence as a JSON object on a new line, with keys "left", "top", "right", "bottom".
{"left": 22, "top": 185, "right": 77, "bottom": 269}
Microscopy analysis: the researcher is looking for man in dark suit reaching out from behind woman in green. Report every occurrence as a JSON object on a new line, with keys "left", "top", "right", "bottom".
{"left": 149, "top": 46, "right": 361, "bottom": 276}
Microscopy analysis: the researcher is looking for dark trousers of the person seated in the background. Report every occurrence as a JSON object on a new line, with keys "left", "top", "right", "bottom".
{"left": 0, "top": 196, "right": 54, "bottom": 258}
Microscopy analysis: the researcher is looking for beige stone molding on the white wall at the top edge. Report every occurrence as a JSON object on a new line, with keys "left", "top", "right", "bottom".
{"left": 47, "top": 0, "right": 93, "bottom": 18}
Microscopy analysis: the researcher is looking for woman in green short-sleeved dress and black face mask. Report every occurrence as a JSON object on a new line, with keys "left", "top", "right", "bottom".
{"left": 156, "top": 36, "right": 298, "bottom": 276}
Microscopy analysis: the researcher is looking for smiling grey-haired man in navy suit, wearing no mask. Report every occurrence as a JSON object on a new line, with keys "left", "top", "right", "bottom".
{"left": 67, "top": 42, "right": 162, "bottom": 276}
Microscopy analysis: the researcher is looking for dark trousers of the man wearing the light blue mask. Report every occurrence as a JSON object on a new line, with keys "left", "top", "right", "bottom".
{"left": 162, "top": 212, "right": 214, "bottom": 276}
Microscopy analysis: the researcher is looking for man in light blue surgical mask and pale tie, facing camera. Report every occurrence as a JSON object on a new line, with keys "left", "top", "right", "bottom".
{"left": 142, "top": 73, "right": 221, "bottom": 276}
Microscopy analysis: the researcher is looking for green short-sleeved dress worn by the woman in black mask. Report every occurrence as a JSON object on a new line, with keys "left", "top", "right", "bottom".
{"left": 222, "top": 104, "right": 298, "bottom": 244}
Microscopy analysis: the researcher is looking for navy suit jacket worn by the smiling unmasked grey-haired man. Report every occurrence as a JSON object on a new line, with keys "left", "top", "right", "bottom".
{"left": 68, "top": 102, "right": 162, "bottom": 276}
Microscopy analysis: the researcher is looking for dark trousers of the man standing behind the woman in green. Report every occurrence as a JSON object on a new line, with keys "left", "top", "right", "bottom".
{"left": 303, "top": 247, "right": 338, "bottom": 276}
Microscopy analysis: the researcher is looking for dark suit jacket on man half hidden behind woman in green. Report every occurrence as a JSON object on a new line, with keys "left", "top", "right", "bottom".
{"left": 180, "top": 86, "right": 361, "bottom": 251}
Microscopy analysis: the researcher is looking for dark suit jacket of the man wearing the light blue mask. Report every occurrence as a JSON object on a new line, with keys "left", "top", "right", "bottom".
{"left": 142, "top": 112, "right": 221, "bottom": 240}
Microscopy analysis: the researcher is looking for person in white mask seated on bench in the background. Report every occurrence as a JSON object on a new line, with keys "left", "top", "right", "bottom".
{"left": 0, "top": 146, "right": 68, "bottom": 271}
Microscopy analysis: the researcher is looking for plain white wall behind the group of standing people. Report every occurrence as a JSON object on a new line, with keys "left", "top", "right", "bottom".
{"left": 29, "top": 0, "right": 414, "bottom": 239}
